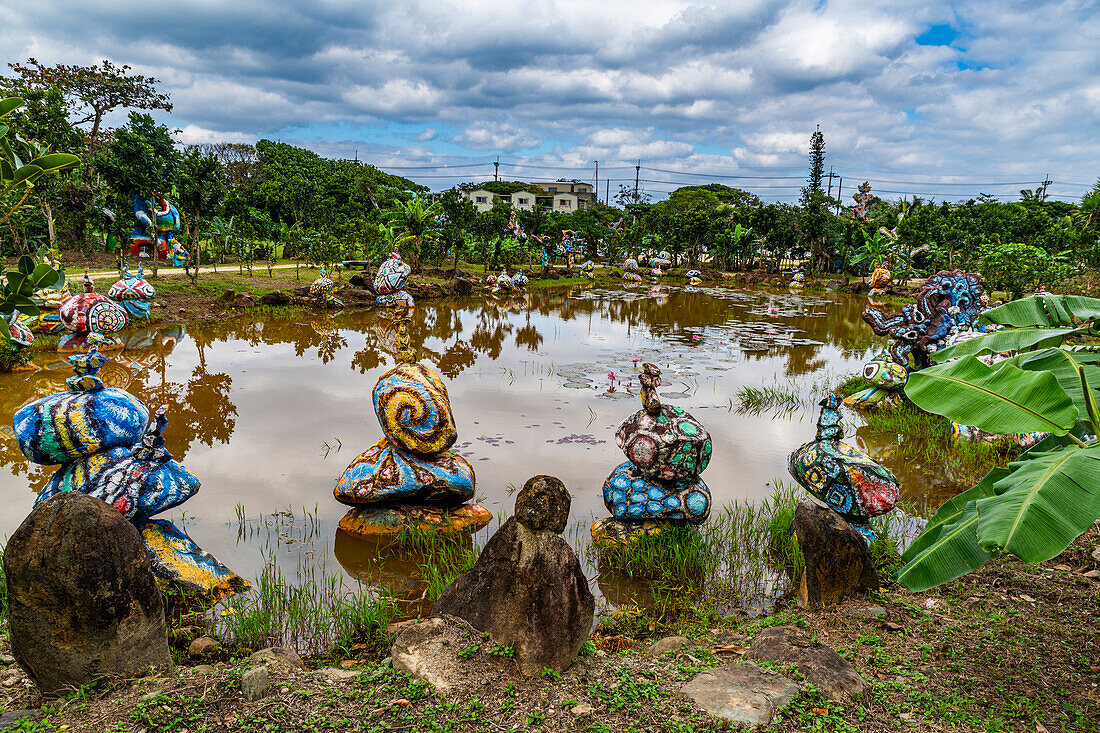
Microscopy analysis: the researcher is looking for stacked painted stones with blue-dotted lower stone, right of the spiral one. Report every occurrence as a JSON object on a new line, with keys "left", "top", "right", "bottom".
{"left": 592, "top": 363, "right": 713, "bottom": 545}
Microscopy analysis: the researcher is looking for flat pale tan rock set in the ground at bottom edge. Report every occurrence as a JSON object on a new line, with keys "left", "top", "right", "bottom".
{"left": 680, "top": 661, "right": 800, "bottom": 725}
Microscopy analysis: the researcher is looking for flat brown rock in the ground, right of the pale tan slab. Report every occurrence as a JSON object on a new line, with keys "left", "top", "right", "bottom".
{"left": 743, "top": 626, "right": 871, "bottom": 703}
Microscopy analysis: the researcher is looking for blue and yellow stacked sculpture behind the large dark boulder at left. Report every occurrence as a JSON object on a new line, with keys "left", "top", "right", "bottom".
{"left": 12, "top": 333, "right": 249, "bottom": 602}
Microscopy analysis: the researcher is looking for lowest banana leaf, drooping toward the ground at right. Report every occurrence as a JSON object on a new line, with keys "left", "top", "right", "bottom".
{"left": 894, "top": 499, "right": 993, "bottom": 591}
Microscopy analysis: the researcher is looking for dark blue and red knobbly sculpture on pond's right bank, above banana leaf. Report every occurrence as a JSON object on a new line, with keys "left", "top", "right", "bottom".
{"left": 864, "top": 270, "right": 985, "bottom": 369}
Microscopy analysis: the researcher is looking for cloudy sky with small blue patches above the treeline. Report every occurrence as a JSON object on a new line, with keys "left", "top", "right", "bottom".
{"left": 0, "top": 0, "right": 1100, "bottom": 200}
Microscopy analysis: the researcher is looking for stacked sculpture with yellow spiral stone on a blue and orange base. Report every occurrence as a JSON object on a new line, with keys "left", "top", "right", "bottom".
{"left": 333, "top": 260, "right": 490, "bottom": 535}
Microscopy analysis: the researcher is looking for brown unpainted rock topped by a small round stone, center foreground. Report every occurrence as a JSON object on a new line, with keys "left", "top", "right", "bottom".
{"left": 433, "top": 477, "right": 596, "bottom": 676}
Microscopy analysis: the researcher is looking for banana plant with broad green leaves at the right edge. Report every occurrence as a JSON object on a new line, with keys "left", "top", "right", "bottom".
{"left": 898, "top": 296, "right": 1100, "bottom": 590}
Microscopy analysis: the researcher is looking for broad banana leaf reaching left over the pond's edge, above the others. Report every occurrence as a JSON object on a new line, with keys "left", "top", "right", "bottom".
{"left": 905, "top": 357, "right": 1078, "bottom": 435}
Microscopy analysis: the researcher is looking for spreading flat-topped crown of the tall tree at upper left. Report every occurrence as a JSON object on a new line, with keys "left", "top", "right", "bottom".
{"left": 8, "top": 58, "right": 172, "bottom": 150}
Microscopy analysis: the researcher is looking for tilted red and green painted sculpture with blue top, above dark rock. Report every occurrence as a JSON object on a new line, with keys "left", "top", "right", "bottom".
{"left": 788, "top": 394, "right": 900, "bottom": 545}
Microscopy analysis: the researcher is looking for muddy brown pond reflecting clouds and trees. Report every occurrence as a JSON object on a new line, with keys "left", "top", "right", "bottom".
{"left": 0, "top": 286, "right": 961, "bottom": 611}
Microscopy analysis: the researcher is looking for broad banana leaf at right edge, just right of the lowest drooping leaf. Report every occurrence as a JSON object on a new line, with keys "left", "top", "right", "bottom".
{"left": 978, "top": 446, "right": 1100, "bottom": 562}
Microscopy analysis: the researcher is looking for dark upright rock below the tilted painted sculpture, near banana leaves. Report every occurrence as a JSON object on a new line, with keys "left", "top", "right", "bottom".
{"left": 794, "top": 499, "right": 879, "bottom": 606}
